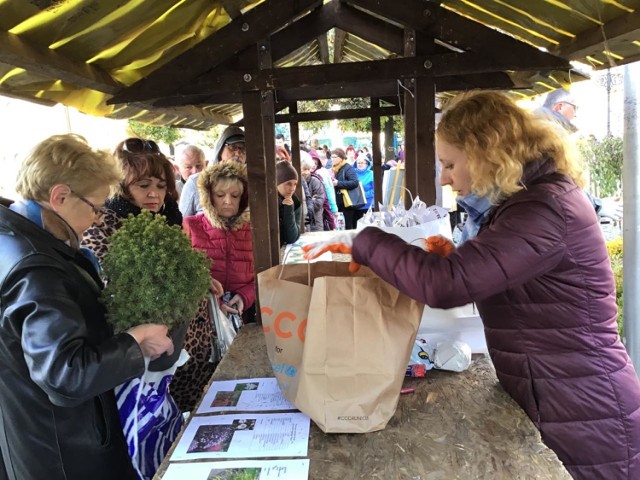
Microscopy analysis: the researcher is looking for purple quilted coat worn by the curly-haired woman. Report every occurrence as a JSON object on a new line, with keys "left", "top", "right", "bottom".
{"left": 353, "top": 161, "right": 640, "bottom": 480}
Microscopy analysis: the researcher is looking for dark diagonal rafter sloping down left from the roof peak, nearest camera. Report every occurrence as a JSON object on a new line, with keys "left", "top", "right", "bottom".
{"left": 109, "top": 0, "right": 321, "bottom": 103}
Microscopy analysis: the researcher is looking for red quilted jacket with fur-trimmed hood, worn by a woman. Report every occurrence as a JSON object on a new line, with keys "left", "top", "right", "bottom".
{"left": 183, "top": 162, "right": 256, "bottom": 310}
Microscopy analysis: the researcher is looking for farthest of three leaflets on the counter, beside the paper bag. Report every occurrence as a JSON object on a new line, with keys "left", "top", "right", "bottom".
{"left": 196, "top": 378, "right": 297, "bottom": 414}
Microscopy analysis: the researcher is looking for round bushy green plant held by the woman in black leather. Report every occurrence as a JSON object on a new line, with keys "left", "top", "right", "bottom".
{"left": 103, "top": 210, "right": 211, "bottom": 330}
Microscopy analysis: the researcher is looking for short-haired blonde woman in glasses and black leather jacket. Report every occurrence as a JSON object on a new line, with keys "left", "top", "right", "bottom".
{"left": 0, "top": 135, "right": 173, "bottom": 480}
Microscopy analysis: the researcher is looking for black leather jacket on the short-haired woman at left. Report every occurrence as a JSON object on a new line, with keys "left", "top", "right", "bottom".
{"left": 0, "top": 206, "right": 144, "bottom": 480}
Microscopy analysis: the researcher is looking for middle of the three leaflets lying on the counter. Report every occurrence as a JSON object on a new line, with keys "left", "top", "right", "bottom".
{"left": 170, "top": 412, "right": 309, "bottom": 461}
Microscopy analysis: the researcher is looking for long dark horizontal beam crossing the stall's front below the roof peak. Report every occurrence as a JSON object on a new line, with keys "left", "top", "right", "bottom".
{"left": 176, "top": 53, "right": 570, "bottom": 96}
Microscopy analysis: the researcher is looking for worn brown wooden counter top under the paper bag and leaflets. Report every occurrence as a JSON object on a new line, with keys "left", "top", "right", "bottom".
{"left": 155, "top": 325, "right": 571, "bottom": 480}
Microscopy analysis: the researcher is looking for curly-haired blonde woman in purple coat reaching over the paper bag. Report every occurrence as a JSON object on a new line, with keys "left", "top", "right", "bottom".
{"left": 310, "top": 92, "right": 640, "bottom": 480}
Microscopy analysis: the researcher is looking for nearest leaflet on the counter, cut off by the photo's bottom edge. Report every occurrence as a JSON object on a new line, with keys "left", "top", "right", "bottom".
{"left": 162, "top": 459, "right": 309, "bottom": 480}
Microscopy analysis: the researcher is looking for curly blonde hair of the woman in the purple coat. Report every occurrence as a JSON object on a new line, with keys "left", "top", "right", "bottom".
{"left": 436, "top": 91, "right": 584, "bottom": 201}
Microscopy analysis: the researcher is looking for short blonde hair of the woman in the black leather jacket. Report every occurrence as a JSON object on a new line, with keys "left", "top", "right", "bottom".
{"left": 16, "top": 134, "right": 122, "bottom": 201}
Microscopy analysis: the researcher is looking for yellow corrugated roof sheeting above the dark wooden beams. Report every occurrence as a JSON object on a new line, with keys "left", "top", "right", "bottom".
{"left": 0, "top": 0, "right": 640, "bottom": 129}
